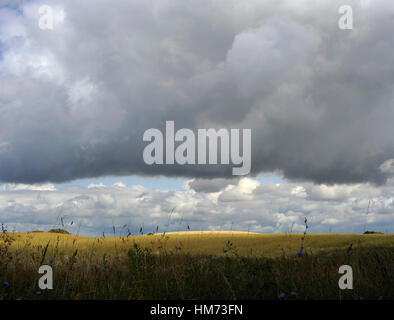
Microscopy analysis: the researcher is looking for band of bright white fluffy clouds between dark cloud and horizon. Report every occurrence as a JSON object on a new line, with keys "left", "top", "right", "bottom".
{"left": 0, "top": 178, "right": 394, "bottom": 235}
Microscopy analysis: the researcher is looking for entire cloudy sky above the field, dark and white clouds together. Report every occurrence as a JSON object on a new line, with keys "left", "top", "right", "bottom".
{"left": 0, "top": 0, "right": 394, "bottom": 236}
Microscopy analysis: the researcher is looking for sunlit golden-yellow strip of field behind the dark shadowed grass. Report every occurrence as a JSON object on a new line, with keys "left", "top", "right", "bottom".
{"left": 9, "top": 231, "right": 394, "bottom": 257}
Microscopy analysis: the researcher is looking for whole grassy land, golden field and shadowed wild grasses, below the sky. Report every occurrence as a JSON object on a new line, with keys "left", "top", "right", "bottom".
{"left": 0, "top": 233, "right": 394, "bottom": 299}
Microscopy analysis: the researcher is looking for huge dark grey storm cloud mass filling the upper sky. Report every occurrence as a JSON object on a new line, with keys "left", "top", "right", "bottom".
{"left": 0, "top": 0, "right": 394, "bottom": 183}
